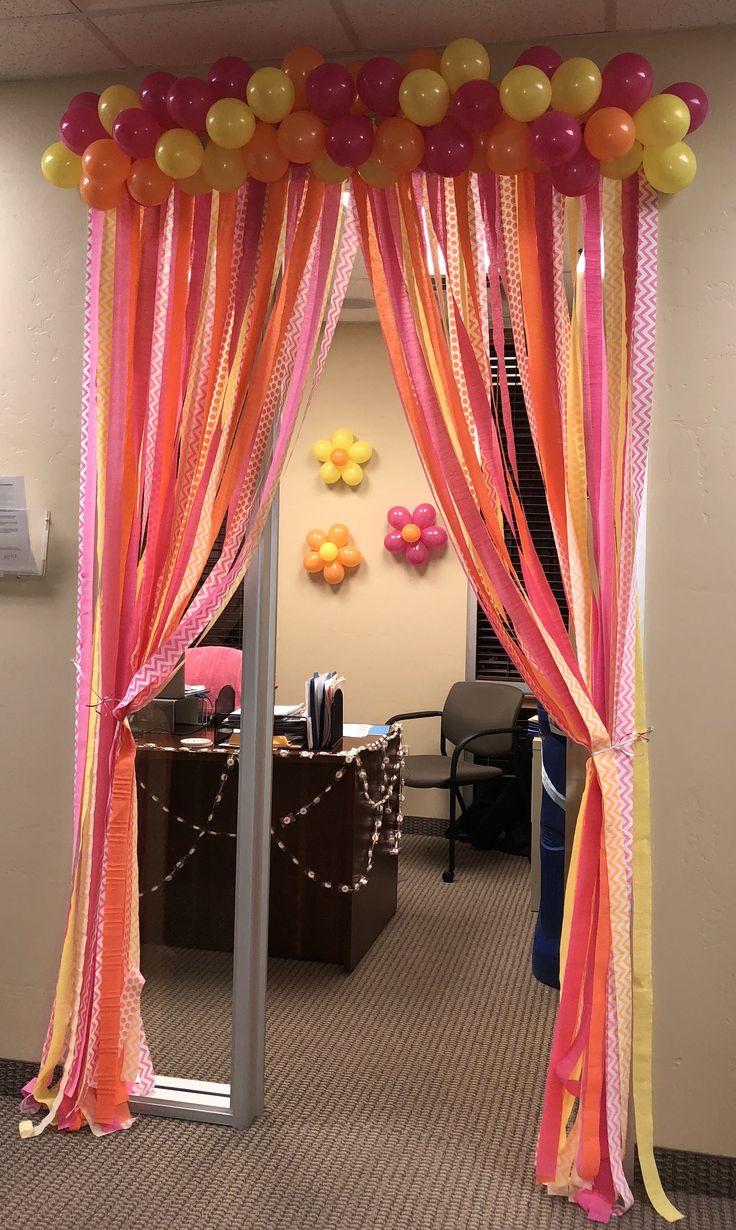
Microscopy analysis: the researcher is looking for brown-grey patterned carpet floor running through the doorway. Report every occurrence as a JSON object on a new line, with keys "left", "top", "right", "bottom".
{"left": 0, "top": 835, "right": 736, "bottom": 1230}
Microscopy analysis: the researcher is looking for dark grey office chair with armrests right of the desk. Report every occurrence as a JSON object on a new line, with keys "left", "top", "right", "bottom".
{"left": 386, "top": 681, "right": 523, "bottom": 883}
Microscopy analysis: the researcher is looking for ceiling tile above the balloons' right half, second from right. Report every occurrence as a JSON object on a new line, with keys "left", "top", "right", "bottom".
{"left": 343, "top": 0, "right": 606, "bottom": 50}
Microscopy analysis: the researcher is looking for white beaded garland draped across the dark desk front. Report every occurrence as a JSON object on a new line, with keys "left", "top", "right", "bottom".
{"left": 138, "top": 727, "right": 406, "bottom": 897}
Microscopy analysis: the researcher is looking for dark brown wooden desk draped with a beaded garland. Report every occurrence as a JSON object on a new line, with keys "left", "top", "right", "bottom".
{"left": 137, "top": 734, "right": 399, "bottom": 970}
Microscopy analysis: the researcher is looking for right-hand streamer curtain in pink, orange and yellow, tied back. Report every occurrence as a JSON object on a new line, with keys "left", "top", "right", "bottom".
{"left": 354, "top": 172, "right": 678, "bottom": 1221}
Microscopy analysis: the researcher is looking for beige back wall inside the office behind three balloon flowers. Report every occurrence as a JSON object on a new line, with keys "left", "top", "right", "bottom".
{"left": 277, "top": 323, "right": 468, "bottom": 815}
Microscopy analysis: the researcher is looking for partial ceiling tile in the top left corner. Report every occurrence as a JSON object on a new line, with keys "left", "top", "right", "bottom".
{"left": 0, "top": 16, "right": 126, "bottom": 81}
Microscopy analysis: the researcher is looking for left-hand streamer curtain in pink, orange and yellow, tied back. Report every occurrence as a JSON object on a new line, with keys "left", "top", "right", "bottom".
{"left": 21, "top": 172, "right": 349, "bottom": 1135}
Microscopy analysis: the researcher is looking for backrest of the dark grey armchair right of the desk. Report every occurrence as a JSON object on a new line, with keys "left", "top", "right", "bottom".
{"left": 442, "top": 680, "right": 524, "bottom": 760}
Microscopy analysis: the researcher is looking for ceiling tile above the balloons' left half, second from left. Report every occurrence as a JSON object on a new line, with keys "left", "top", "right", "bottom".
{"left": 90, "top": 0, "right": 353, "bottom": 65}
